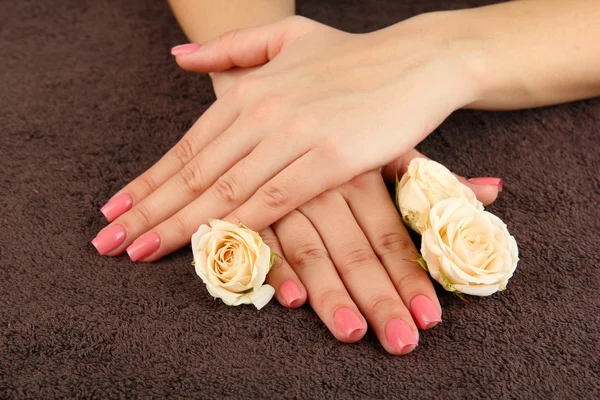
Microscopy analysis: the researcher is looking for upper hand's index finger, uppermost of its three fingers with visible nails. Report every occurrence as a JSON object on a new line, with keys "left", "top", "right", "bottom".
{"left": 102, "top": 100, "right": 239, "bottom": 222}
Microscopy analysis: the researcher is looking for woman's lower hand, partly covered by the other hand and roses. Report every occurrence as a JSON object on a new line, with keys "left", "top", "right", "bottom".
{"left": 261, "top": 151, "right": 500, "bottom": 354}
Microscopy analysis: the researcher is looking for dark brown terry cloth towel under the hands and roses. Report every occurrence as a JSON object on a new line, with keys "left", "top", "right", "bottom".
{"left": 0, "top": 0, "right": 600, "bottom": 399}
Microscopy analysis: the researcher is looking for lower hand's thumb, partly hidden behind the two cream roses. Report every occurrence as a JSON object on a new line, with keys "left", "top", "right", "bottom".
{"left": 381, "top": 149, "right": 502, "bottom": 206}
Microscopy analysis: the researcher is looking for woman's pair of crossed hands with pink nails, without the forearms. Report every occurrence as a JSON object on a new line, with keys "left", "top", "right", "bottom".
{"left": 93, "top": 17, "right": 498, "bottom": 354}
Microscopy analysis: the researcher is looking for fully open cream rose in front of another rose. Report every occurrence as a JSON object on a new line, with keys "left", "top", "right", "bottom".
{"left": 421, "top": 199, "right": 519, "bottom": 296}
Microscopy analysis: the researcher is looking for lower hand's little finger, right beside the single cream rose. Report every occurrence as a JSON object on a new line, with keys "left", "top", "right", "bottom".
{"left": 260, "top": 227, "right": 306, "bottom": 308}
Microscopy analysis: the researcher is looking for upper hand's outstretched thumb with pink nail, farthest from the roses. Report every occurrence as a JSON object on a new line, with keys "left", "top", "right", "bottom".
{"left": 171, "top": 16, "right": 317, "bottom": 72}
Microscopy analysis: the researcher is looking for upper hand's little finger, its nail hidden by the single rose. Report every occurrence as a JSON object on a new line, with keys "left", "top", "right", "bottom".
{"left": 225, "top": 150, "right": 353, "bottom": 230}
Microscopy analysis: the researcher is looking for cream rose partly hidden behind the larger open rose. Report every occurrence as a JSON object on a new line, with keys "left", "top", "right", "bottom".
{"left": 396, "top": 158, "right": 483, "bottom": 235}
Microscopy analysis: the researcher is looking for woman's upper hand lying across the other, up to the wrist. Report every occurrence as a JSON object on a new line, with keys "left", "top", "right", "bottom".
{"left": 94, "top": 17, "right": 488, "bottom": 261}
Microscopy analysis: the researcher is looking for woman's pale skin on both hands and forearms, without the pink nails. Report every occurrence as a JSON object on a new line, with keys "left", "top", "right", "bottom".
{"left": 92, "top": 0, "right": 600, "bottom": 354}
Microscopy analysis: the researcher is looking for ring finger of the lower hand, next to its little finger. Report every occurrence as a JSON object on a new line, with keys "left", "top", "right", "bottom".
{"left": 273, "top": 211, "right": 367, "bottom": 343}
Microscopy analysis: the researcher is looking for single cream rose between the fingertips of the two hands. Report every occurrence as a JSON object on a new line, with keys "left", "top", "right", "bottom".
{"left": 192, "top": 220, "right": 275, "bottom": 310}
